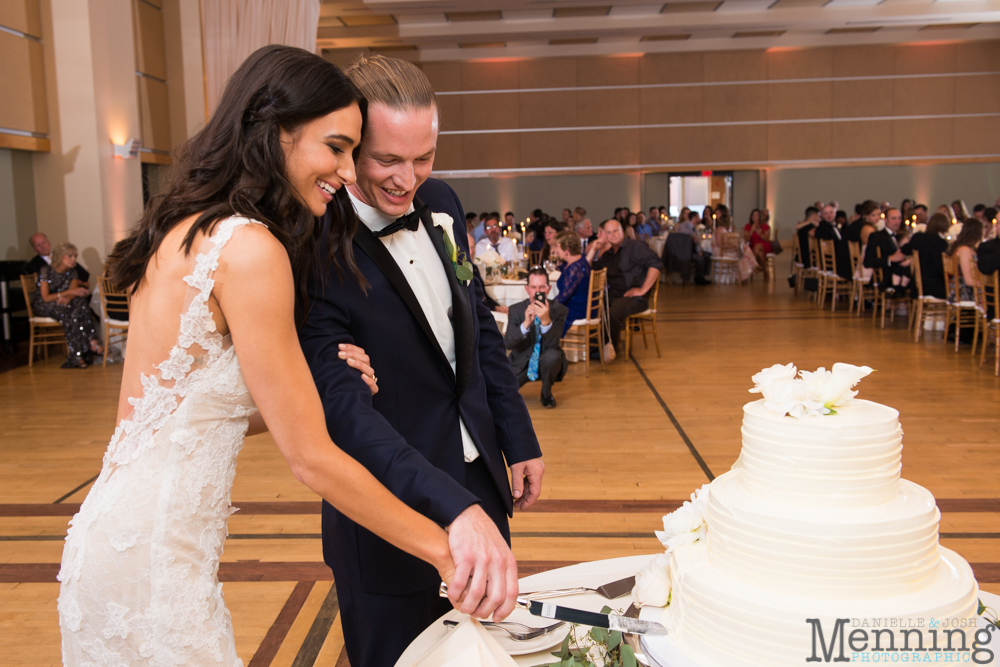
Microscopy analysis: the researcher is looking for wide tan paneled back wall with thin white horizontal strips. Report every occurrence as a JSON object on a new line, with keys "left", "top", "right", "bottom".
{"left": 421, "top": 40, "right": 1000, "bottom": 175}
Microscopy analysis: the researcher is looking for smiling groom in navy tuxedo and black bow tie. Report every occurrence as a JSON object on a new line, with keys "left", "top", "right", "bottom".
{"left": 300, "top": 56, "right": 544, "bottom": 667}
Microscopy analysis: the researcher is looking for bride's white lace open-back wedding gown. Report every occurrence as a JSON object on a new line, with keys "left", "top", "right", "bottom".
{"left": 59, "top": 217, "right": 260, "bottom": 667}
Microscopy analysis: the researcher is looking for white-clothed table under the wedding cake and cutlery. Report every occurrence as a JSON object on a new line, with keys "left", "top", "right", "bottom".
{"left": 396, "top": 554, "right": 1000, "bottom": 667}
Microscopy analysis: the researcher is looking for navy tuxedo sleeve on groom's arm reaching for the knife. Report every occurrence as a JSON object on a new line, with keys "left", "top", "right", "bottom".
{"left": 299, "top": 276, "right": 480, "bottom": 526}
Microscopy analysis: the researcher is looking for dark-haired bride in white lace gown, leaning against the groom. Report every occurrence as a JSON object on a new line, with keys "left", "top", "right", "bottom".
{"left": 59, "top": 46, "right": 468, "bottom": 665}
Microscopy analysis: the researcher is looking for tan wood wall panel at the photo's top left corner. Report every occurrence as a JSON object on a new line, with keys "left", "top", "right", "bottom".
{"left": 0, "top": 0, "right": 49, "bottom": 151}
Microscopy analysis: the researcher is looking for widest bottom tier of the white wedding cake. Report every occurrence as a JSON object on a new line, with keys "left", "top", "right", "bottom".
{"left": 642, "top": 543, "right": 979, "bottom": 667}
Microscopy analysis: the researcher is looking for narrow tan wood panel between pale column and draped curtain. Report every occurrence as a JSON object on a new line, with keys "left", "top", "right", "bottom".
{"left": 132, "top": 0, "right": 172, "bottom": 164}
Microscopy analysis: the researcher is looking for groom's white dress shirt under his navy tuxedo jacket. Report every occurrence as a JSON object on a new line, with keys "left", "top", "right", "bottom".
{"left": 348, "top": 191, "right": 479, "bottom": 463}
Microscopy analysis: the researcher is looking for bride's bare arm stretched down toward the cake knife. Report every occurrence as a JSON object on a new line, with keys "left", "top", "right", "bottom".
{"left": 214, "top": 227, "right": 454, "bottom": 582}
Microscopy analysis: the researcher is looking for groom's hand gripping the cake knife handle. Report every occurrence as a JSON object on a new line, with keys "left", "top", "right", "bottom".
{"left": 448, "top": 505, "right": 517, "bottom": 621}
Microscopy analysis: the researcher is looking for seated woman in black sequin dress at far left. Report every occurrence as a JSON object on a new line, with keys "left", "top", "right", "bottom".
{"left": 32, "top": 243, "right": 104, "bottom": 368}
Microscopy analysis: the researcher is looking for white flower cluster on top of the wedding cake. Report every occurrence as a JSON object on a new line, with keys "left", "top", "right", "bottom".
{"left": 750, "top": 363, "right": 872, "bottom": 418}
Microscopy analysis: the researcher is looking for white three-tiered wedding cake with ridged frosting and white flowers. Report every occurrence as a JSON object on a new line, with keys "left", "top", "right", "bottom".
{"left": 634, "top": 364, "right": 978, "bottom": 667}
